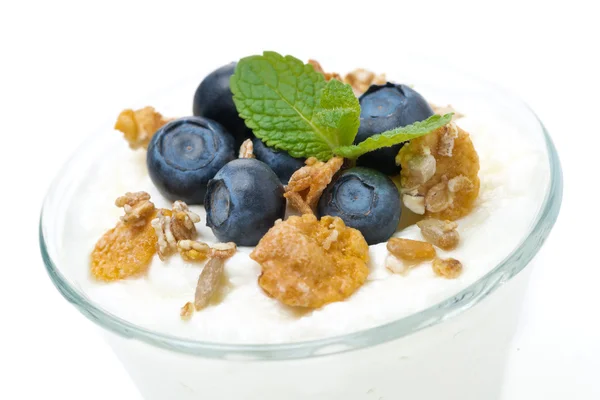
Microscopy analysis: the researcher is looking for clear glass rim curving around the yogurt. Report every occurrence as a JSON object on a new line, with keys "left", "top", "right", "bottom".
{"left": 39, "top": 89, "right": 563, "bottom": 360}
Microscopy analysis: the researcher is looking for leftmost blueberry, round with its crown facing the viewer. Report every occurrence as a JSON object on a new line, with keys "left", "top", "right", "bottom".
{"left": 146, "top": 117, "right": 236, "bottom": 204}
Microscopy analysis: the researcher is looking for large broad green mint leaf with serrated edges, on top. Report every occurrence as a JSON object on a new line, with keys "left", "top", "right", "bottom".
{"left": 230, "top": 52, "right": 360, "bottom": 160}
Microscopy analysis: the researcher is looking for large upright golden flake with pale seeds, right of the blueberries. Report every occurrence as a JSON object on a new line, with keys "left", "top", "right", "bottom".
{"left": 396, "top": 123, "right": 479, "bottom": 221}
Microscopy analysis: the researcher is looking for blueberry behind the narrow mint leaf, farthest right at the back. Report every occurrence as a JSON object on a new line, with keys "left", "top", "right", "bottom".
{"left": 355, "top": 82, "right": 433, "bottom": 175}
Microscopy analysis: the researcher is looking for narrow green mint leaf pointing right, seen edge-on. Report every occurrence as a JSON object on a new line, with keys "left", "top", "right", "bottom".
{"left": 334, "top": 113, "right": 452, "bottom": 159}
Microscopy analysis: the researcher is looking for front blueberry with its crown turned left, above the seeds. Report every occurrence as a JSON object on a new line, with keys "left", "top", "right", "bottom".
{"left": 204, "top": 158, "right": 286, "bottom": 246}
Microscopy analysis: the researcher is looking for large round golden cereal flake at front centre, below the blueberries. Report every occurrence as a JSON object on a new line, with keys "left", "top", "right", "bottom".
{"left": 250, "top": 214, "right": 369, "bottom": 308}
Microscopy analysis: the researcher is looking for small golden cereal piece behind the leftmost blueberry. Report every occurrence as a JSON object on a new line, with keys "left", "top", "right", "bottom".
{"left": 115, "top": 107, "right": 169, "bottom": 149}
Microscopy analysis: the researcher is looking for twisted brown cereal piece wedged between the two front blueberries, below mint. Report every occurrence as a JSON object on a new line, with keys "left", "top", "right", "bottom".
{"left": 284, "top": 157, "right": 344, "bottom": 214}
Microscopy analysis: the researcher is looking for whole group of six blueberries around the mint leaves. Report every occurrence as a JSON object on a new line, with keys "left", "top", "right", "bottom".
{"left": 147, "top": 63, "right": 433, "bottom": 246}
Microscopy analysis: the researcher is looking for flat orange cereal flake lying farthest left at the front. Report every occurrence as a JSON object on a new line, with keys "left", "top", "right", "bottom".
{"left": 91, "top": 218, "right": 156, "bottom": 281}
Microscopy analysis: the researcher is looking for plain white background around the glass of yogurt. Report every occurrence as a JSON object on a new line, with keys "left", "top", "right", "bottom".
{"left": 0, "top": 0, "right": 600, "bottom": 400}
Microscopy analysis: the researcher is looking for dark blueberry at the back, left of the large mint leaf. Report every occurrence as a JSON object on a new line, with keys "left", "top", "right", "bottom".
{"left": 194, "top": 62, "right": 252, "bottom": 147}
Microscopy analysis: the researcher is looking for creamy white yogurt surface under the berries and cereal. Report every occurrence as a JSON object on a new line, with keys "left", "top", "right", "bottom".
{"left": 60, "top": 94, "right": 549, "bottom": 343}
